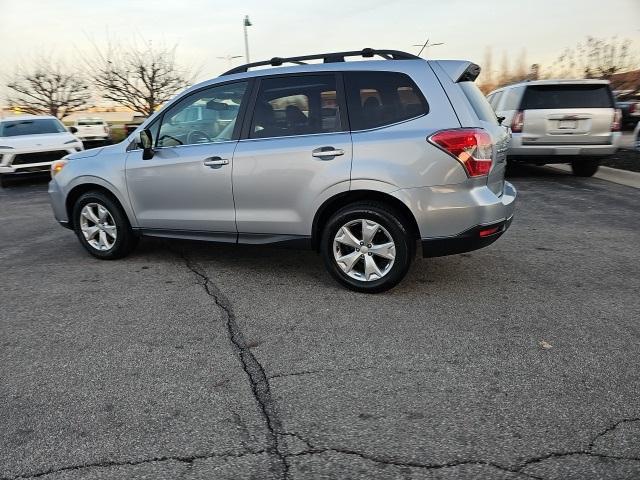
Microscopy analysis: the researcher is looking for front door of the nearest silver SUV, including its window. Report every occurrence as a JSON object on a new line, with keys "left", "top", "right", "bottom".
{"left": 126, "top": 82, "right": 248, "bottom": 236}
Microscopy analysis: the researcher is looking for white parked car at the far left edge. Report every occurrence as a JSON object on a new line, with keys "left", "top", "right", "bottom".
{"left": 0, "top": 115, "right": 83, "bottom": 186}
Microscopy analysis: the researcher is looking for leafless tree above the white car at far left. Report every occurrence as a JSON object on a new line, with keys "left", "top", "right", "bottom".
{"left": 7, "top": 59, "right": 91, "bottom": 119}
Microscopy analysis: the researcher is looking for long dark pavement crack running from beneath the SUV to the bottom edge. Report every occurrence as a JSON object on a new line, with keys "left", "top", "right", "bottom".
{"left": 179, "top": 253, "right": 289, "bottom": 480}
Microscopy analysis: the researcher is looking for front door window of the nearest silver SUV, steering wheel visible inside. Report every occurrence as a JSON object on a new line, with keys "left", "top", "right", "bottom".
{"left": 156, "top": 82, "right": 247, "bottom": 147}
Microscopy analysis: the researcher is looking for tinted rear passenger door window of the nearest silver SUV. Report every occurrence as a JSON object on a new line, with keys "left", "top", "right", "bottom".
{"left": 249, "top": 74, "right": 341, "bottom": 138}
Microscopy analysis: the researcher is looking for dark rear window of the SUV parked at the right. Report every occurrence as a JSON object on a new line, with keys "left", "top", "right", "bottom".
{"left": 520, "top": 84, "right": 613, "bottom": 110}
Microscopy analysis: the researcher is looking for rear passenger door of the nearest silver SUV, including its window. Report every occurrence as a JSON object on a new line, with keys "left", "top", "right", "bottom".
{"left": 233, "top": 73, "right": 352, "bottom": 238}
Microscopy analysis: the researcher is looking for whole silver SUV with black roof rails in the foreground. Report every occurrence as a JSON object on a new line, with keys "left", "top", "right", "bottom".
{"left": 49, "top": 49, "right": 516, "bottom": 292}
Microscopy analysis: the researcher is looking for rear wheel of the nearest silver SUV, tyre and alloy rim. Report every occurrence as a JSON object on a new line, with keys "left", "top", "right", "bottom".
{"left": 321, "top": 202, "right": 415, "bottom": 293}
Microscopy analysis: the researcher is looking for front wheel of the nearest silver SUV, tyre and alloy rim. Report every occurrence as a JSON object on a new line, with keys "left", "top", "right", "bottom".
{"left": 73, "top": 192, "right": 138, "bottom": 260}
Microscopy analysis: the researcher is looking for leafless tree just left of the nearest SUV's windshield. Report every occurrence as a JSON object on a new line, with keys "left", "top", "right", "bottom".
{"left": 88, "top": 43, "right": 190, "bottom": 115}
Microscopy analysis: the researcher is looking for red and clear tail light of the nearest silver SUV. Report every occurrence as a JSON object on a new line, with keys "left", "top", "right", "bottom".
{"left": 429, "top": 128, "right": 493, "bottom": 177}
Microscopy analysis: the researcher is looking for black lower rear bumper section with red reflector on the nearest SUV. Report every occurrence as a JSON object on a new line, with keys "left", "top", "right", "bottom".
{"left": 422, "top": 215, "right": 513, "bottom": 257}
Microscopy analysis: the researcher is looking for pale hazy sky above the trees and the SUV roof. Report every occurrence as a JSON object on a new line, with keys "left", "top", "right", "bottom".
{"left": 0, "top": 0, "right": 640, "bottom": 88}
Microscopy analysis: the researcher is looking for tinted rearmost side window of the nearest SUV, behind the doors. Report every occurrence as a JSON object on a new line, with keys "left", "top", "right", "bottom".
{"left": 344, "top": 72, "right": 429, "bottom": 130}
